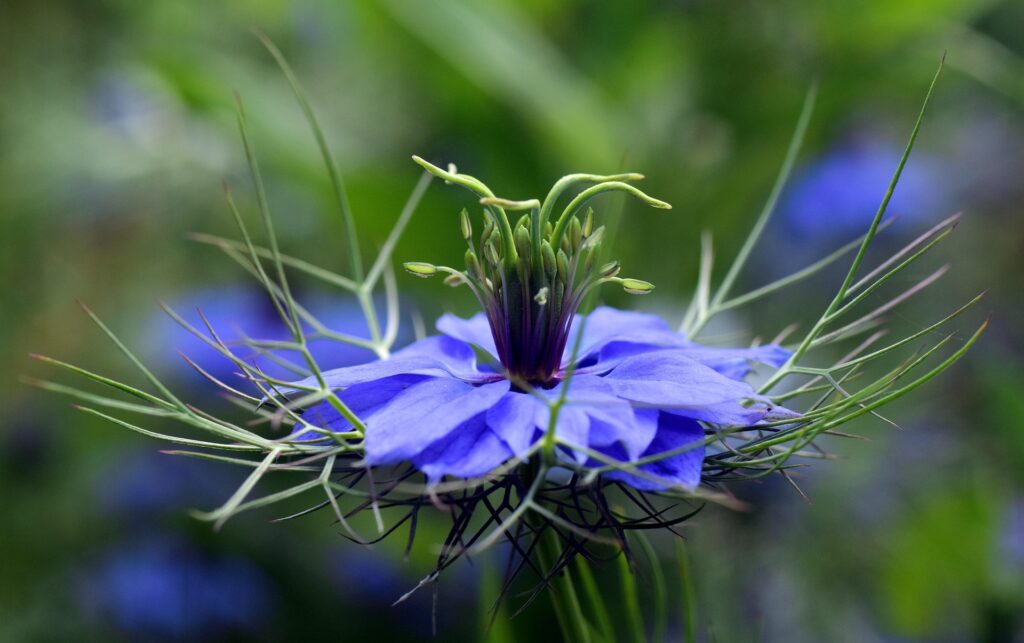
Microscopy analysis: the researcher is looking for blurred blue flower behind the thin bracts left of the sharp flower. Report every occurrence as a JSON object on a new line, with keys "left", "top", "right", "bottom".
{"left": 147, "top": 285, "right": 408, "bottom": 386}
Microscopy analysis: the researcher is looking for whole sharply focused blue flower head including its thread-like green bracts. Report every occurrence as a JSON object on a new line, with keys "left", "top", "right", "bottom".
{"left": 39, "top": 57, "right": 986, "bottom": 638}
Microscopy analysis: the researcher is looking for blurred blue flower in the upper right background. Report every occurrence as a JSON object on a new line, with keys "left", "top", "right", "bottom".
{"left": 778, "top": 132, "right": 950, "bottom": 241}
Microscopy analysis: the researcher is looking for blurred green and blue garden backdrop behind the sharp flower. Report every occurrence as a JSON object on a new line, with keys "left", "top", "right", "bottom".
{"left": 0, "top": 0, "right": 1024, "bottom": 641}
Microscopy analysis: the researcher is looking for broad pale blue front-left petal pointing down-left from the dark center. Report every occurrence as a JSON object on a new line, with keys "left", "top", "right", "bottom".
{"left": 366, "top": 378, "right": 509, "bottom": 465}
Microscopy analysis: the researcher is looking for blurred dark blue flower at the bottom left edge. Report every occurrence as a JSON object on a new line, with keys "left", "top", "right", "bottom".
{"left": 80, "top": 538, "right": 274, "bottom": 640}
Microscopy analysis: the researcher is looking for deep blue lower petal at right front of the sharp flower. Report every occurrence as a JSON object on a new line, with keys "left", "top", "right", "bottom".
{"left": 604, "top": 413, "right": 705, "bottom": 491}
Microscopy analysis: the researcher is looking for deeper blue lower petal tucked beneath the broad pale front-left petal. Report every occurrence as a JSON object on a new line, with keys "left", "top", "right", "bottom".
{"left": 413, "top": 413, "right": 513, "bottom": 484}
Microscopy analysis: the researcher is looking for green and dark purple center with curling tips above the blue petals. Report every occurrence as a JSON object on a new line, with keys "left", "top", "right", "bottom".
{"left": 406, "top": 157, "right": 671, "bottom": 387}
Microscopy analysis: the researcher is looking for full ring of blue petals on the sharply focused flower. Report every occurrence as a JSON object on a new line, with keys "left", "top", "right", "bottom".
{"left": 299, "top": 307, "right": 788, "bottom": 489}
